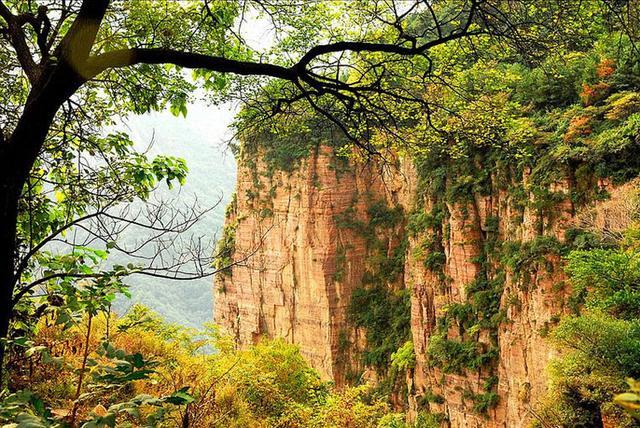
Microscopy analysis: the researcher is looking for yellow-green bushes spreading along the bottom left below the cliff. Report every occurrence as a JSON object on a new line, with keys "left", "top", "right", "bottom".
{"left": 0, "top": 306, "right": 426, "bottom": 428}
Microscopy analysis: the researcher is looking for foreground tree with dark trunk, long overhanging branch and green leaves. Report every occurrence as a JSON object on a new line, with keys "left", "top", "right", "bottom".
{"left": 0, "top": 0, "right": 632, "bottom": 377}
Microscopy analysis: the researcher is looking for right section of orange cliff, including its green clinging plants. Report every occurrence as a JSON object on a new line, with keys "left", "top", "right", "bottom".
{"left": 405, "top": 166, "right": 574, "bottom": 427}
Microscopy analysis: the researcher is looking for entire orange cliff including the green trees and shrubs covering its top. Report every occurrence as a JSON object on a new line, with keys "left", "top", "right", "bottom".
{"left": 215, "top": 29, "right": 640, "bottom": 427}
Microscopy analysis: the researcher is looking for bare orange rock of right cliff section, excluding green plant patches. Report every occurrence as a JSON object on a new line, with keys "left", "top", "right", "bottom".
{"left": 405, "top": 168, "right": 573, "bottom": 427}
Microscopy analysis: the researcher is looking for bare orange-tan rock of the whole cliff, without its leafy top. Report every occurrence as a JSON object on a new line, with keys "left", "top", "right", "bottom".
{"left": 215, "top": 148, "right": 588, "bottom": 427}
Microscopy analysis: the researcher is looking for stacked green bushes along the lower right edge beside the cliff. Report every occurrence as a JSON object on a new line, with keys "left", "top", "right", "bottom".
{"left": 542, "top": 227, "right": 640, "bottom": 426}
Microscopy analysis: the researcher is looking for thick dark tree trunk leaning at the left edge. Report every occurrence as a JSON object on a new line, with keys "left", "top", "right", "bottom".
{"left": 0, "top": 0, "right": 109, "bottom": 386}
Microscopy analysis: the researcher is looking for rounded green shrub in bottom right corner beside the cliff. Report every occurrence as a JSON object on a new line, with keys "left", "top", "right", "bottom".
{"left": 541, "top": 311, "right": 640, "bottom": 426}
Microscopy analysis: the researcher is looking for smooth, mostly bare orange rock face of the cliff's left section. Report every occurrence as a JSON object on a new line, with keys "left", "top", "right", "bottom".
{"left": 215, "top": 148, "right": 404, "bottom": 385}
